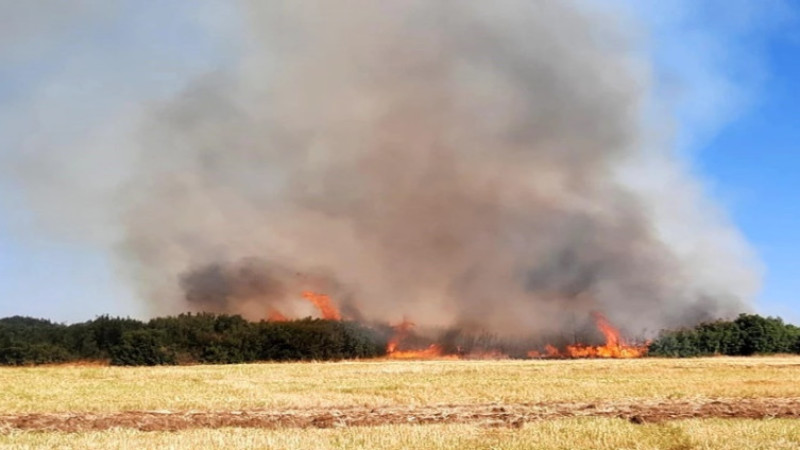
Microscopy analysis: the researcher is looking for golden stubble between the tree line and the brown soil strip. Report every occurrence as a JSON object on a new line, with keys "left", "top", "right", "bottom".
{"left": 0, "top": 357, "right": 800, "bottom": 414}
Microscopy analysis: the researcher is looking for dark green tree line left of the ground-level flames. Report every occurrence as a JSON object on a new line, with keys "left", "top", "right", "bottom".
{"left": 0, "top": 313, "right": 387, "bottom": 365}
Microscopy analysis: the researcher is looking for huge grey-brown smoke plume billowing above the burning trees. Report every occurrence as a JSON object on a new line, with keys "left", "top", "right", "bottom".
{"left": 112, "top": 0, "right": 757, "bottom": 333}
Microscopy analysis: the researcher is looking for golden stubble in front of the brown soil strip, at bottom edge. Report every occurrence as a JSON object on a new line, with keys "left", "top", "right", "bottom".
{"left": 0, "top": 417, "right": 800, "bottom": 450}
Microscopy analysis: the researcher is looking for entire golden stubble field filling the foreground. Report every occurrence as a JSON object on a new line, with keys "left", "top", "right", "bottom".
{"left": 0, "top": 356, "right": 800, "bottom": 449}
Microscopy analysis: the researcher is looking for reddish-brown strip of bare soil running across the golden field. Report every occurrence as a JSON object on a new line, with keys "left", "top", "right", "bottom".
{"left": 0, "top": 398, "right": 800, "bottom": 432}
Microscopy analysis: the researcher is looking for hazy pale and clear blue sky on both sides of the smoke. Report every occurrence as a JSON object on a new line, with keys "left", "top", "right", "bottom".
{"left": 0, "top": 0, "right": 800, "bottom": 323}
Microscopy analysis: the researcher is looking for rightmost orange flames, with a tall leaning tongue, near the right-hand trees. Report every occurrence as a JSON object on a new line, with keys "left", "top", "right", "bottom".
{"left": 528, "top": 312, "right": 647, "bottom": 358}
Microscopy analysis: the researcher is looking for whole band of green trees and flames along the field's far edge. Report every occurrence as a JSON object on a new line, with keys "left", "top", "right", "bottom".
{"left": 0, "top": 313, "right": 800, "bottom": 365}
